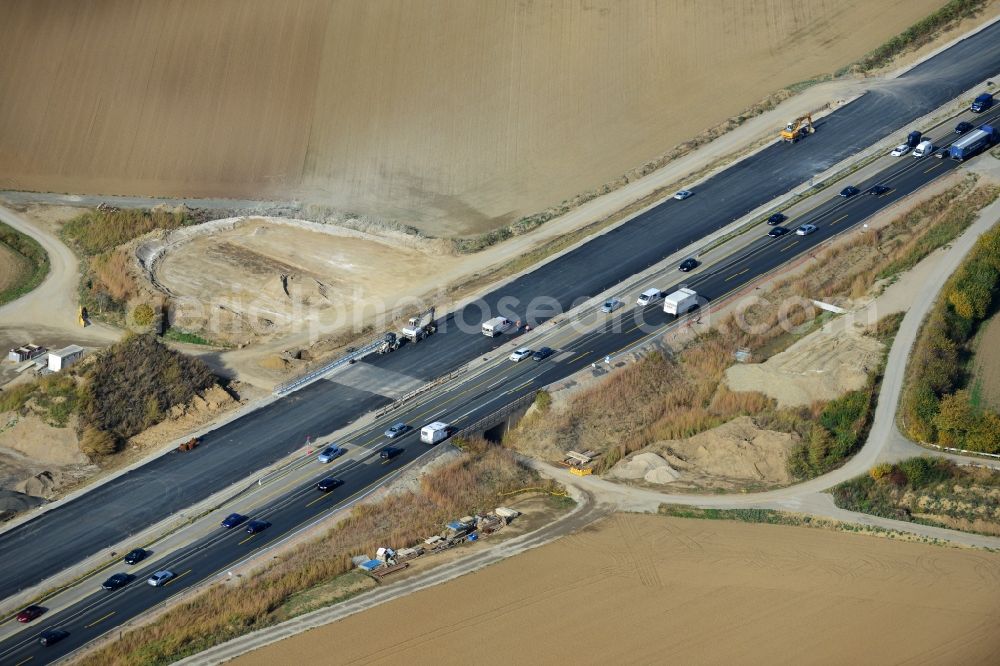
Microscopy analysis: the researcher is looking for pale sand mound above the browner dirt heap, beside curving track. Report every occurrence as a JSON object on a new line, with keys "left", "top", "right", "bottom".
{"left": 726, "top": 320, "right": 883, "bottom": 407}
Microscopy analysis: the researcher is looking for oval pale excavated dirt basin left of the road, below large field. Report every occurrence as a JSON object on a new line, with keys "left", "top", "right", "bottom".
{"left": 149, "top": 218, "right": 460, "bottom": 344}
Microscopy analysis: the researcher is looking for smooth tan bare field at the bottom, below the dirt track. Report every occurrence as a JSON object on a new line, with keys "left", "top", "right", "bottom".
{"left": 231, "top": 514, "right": 1000, "bottom": 666}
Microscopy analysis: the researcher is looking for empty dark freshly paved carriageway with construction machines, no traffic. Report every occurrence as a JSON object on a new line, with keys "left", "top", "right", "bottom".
{"left": 0, "top": 24, "right": 1000, "bottom": 596}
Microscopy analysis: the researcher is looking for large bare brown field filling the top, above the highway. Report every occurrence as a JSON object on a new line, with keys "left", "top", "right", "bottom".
{"left": 0, "top": 0, "right": 942, "bottom": 235}
